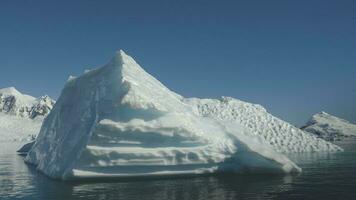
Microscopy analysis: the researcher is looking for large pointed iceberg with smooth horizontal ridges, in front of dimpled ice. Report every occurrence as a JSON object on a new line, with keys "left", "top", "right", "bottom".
{"left": 26, "top": 51, "right": 306, "bottom": 179}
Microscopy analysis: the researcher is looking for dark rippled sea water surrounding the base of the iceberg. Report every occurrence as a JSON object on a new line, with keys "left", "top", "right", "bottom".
{"left": 0, "top": 140, "right": 356, "bottom": 200}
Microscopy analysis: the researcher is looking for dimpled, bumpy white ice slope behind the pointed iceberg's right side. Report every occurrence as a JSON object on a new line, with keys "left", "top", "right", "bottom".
{"left": 185, "top": 97, "right": 340, "bottom": 153}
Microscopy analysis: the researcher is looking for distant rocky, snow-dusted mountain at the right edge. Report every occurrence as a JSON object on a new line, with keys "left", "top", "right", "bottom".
{"left": 301, "top": 112, "right": 356, "bottom": 141}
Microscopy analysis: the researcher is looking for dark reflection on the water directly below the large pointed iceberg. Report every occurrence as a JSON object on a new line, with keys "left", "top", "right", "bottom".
{"left": 24, "top": 162, "right": 293, "bottom": 200}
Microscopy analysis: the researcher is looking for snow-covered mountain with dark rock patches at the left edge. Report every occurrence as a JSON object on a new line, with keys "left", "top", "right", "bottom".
{"left": 0, "top": 87, "right": 55, "bottom": 141}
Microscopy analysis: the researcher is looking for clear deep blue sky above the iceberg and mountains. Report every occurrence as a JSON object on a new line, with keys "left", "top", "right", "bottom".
{"left": 0, "top": 0, "right": 356, "bottom": 125}
